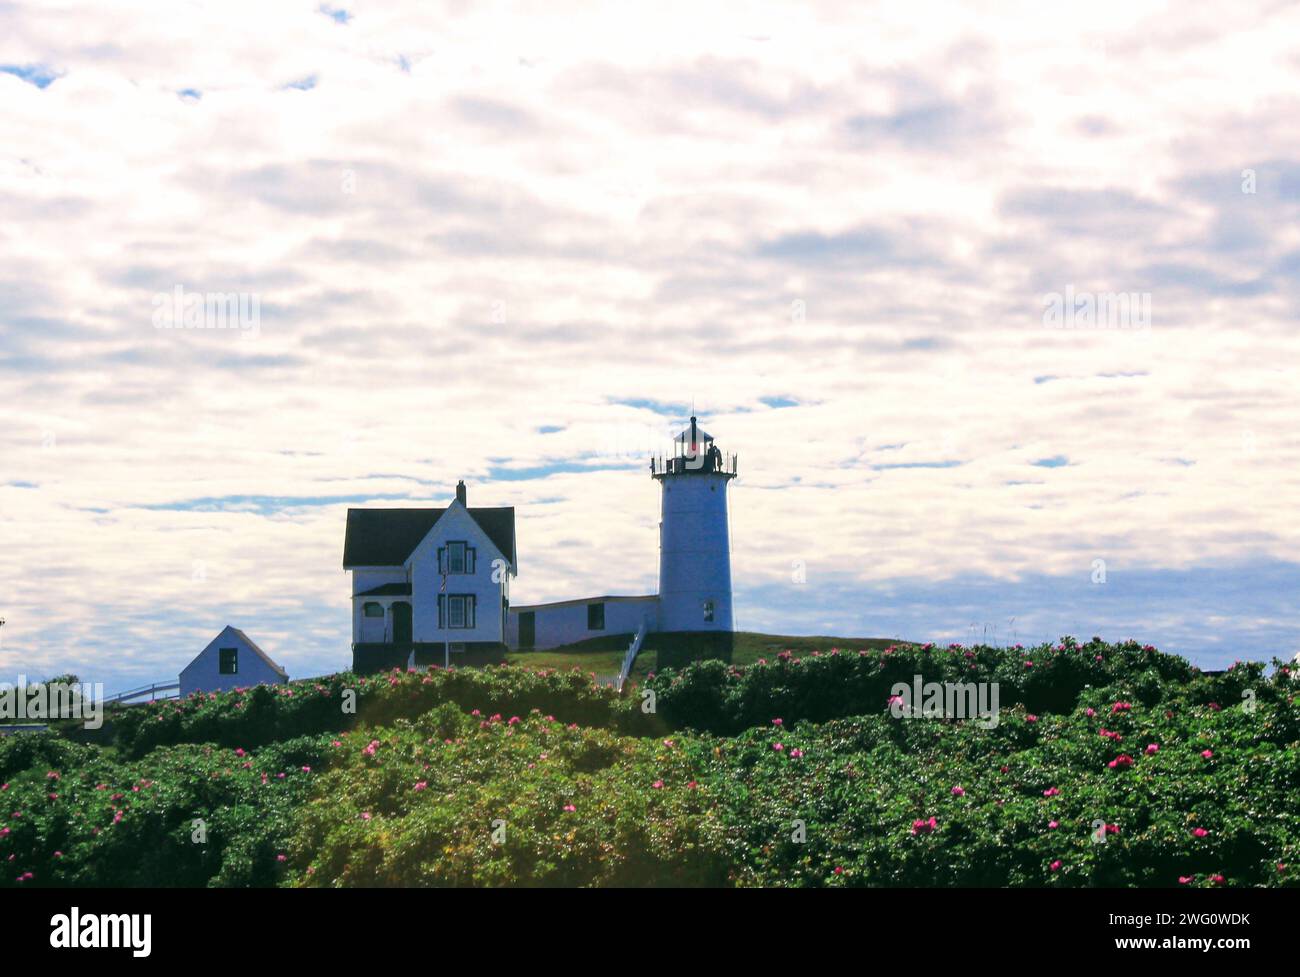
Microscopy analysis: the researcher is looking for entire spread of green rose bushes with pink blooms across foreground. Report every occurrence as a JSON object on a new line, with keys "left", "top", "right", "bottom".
{"left": 0, "top": 635, "right": 1300, "bottom": 887}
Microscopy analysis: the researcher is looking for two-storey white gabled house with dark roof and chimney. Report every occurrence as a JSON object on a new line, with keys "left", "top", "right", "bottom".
{"left": 343, "top": 482, "right": 517, "bottom": 672}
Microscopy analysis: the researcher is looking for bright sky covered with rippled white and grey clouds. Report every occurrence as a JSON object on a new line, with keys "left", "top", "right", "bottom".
{"left": 0, "top": 0, "right": 1300, "bottom": 691}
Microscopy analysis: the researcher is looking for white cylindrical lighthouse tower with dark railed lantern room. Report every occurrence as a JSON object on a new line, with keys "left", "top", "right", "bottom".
{"left": 650, "top": 417, "right": 736, "bottom": 660}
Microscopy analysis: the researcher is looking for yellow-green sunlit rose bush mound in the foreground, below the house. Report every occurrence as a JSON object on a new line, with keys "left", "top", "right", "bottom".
{"left": 291, "top": 704, "right": 727, "bottom": 886}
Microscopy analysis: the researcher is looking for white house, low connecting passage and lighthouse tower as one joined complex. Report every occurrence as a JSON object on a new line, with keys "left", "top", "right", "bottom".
{"left": 343, "top": 417, "right": 736, "bottom": 672}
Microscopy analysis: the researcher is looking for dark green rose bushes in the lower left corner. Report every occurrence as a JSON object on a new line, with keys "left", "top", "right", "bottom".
{"left": 0, "top": 735, "right": 329, "bottom": 887}
